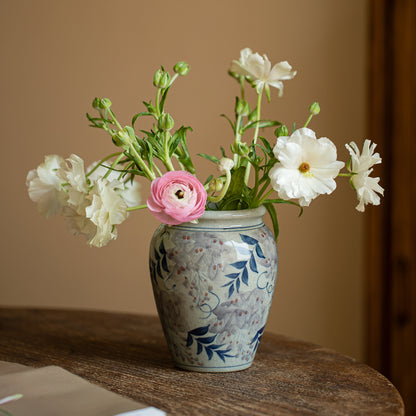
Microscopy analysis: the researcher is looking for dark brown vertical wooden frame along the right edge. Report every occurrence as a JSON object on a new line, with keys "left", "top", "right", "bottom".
{"left": 367, "top": 0, "right": 416, "bottom": 415}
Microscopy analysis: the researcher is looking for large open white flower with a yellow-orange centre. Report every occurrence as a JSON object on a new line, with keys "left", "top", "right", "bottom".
{"left": 269, "top": 127, "right": 344, "bottom": 206}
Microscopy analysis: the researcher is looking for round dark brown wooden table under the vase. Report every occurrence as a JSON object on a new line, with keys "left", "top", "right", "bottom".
{"left": 0, "top": 308, "right": 404, "bottom": 416}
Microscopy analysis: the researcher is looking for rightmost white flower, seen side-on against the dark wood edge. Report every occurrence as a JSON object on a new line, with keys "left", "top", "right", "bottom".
{"left": 345, "top": 140, "right": 384, "bottom": 212}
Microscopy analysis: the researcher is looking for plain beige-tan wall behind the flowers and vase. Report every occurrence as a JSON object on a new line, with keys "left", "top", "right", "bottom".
{"left": 0, "top": 0, "right": 366, "bottom": 358}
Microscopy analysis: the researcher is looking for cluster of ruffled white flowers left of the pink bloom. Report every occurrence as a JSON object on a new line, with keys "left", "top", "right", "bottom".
{"left": 27, "top": 155, "right": 140, "bottom": 247}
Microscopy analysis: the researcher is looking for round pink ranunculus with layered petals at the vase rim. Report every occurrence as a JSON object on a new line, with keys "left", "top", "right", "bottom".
{"left": 147, "top": 170, "right": 207, "bottom": 225}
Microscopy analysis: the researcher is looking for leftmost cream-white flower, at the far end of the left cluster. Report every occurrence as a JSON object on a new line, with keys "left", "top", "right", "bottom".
{"left": 26, "top": 155, "right": 67, "bottom": 218}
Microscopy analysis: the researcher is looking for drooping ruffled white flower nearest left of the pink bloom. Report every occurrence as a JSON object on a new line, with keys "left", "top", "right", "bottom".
{"left": 85, "top": 179, "right": 128, "bottom": 247}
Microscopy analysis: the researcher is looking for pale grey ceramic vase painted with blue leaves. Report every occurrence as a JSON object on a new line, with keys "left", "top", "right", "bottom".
{"left": 149, "top": 207, "right": 277, "bottom": 372}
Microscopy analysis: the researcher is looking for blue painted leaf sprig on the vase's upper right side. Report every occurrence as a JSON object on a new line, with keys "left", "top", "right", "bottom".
{"left": 223, "top": 234, "right": 265, "bottom": 298}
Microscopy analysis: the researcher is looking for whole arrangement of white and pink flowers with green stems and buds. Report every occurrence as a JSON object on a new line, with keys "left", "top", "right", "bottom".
{"left": 27, "top": 48, "right": 383, "bottom": 247}
